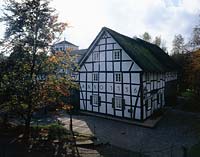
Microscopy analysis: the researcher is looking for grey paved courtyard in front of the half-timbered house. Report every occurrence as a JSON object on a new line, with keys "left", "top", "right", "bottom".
{"left": 56, "top": 110, "right": 200, "bottom": 157}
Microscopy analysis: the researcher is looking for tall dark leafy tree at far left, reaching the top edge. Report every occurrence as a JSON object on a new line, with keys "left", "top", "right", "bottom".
{"left": 0, "top": 0, "right": 67, "bottom": 135}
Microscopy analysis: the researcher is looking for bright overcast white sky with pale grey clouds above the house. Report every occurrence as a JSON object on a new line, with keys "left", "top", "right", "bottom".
{"left": 0, "top": 0, "right": 200, "bottom": 50}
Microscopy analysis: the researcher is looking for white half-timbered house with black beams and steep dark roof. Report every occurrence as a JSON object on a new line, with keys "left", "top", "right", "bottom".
{"left": 79, "top": 27, "right": 177, "bottom": 120}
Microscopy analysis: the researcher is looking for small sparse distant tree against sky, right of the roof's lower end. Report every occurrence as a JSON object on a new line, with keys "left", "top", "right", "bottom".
{"left": 172, "top": 34, "right": 185, "bottom": 55}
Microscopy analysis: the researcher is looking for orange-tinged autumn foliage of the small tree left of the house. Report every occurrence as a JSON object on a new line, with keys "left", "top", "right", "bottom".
{"left": 39, "top": 51, "right": 78, "bottom": 108}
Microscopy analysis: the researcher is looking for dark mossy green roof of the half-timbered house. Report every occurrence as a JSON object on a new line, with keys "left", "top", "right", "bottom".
{"left": 80, "top": 27, "right": 179, "bottom": 72}
